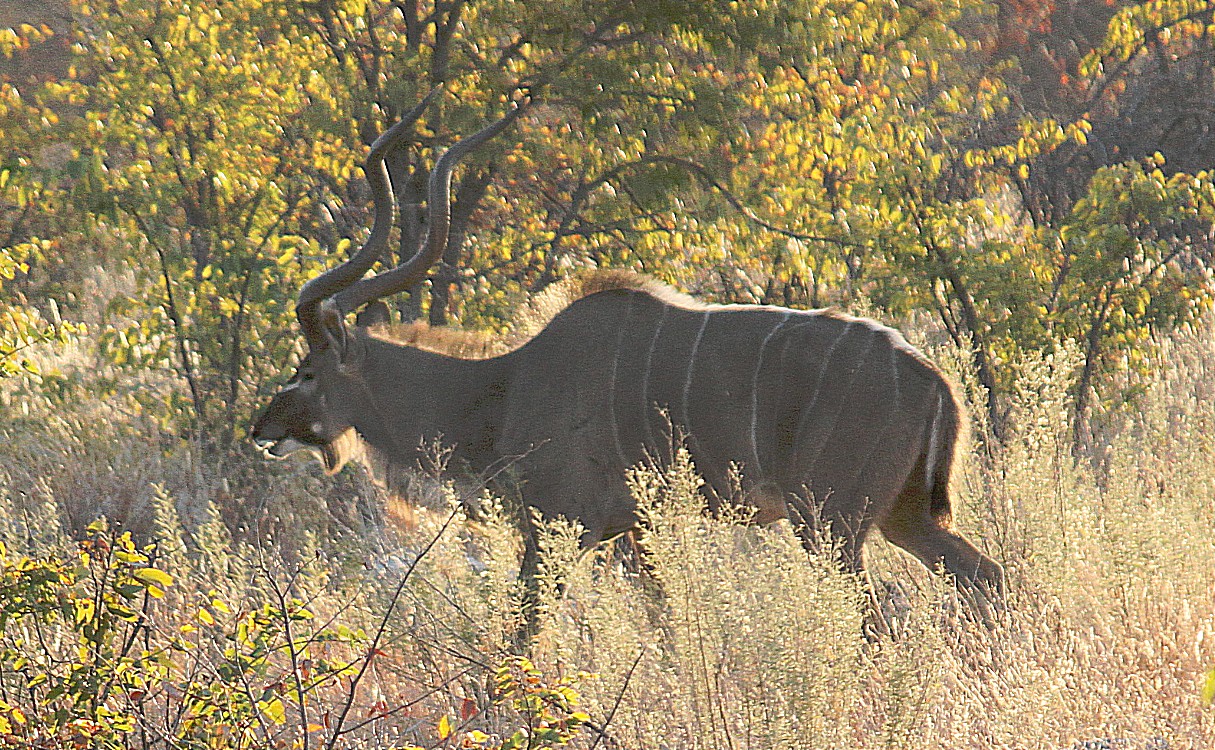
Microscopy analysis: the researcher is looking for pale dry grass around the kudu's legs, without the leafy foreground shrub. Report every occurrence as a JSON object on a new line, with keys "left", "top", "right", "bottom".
{"left": 0, "top": 307, "right": 1215, "bottom": 750}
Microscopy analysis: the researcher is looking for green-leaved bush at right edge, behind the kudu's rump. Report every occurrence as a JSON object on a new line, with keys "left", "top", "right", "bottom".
{"left": 918, "top": 154, "right": 1215, "bottom": 447}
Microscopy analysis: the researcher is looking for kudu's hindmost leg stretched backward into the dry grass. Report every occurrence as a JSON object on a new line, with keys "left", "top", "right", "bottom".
{"left": 878, "top": 489, "right": 1005, "bottom": 625}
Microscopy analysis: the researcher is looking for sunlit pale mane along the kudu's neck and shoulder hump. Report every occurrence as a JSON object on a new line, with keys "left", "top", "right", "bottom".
{"left": 371, "top": 270, "right": 707, "bottom": 360}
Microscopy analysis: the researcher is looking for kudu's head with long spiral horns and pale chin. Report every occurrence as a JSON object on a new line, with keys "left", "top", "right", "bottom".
{"left": 252, "top": 89, "right": 530, "bottom": 472}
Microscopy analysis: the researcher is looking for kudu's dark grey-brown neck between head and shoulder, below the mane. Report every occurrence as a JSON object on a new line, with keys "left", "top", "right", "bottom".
{"left": 354, "top": 337, "right": 509, "bottom": 467}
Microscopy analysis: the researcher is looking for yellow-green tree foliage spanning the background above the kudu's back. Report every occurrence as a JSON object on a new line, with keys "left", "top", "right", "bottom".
{"left": 0, "top": 0, "right": 1211, "bottom": 453}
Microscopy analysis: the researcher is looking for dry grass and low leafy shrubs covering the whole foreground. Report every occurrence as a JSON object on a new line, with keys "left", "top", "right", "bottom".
{"left": 0, "top": 313, "right": 1215, "bottom": 750}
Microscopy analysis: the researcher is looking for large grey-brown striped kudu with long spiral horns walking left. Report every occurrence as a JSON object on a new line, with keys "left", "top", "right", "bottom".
{"left": 253, "top": 101, "right": 1004, "bottom": 617}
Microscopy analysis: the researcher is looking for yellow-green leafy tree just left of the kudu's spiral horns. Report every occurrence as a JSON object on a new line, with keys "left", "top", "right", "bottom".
{"left": 58, "top": 0, "right": 350, "bottom": 447}
